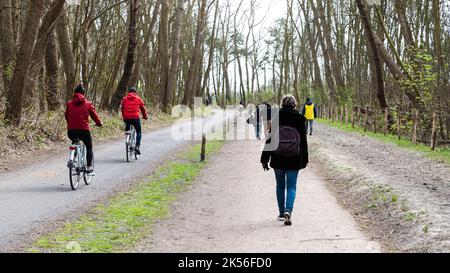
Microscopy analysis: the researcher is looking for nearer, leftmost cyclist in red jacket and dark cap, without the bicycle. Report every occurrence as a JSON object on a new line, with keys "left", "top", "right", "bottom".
{"left": 65, "top": 84, "right": 103, "bottom": 175}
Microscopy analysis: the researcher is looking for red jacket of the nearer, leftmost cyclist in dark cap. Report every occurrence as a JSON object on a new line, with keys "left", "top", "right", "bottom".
{"left": 66, "top": 93, "right": 102, "bottom": 131}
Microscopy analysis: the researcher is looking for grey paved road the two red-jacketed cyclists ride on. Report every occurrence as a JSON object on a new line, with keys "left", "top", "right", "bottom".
{"left": 0, "top": 110, "right": 230, "bottom": 249}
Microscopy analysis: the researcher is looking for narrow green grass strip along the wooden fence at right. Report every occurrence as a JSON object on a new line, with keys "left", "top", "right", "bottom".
{"left": 317, "top": 119, "right": 450, "bottom": 164}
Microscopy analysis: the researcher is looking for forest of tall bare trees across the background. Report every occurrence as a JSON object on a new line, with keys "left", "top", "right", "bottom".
{"left": 0, "top": 0, "right": 450, "bottom": 143}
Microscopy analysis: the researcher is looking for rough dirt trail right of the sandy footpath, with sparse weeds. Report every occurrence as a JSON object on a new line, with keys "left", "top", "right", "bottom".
{"left": 309, "top": 122, "right": 450, "bottom": 252}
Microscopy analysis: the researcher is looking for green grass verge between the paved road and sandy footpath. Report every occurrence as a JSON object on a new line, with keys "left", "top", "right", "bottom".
{"left": 28, "top": 141, "right": 223, "bottom": 253}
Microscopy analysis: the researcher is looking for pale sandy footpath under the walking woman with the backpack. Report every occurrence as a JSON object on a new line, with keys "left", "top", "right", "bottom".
{"left": 134, "top": 138, "right": 380, "bottom": 253}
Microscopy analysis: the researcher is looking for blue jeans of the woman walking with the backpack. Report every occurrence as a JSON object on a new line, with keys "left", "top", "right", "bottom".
{"left": 275, "top": 170, "right": 299, "bottom": 214}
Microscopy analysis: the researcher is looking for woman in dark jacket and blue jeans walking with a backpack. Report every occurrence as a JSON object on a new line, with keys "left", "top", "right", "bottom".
{"left": 261, "top": 95, "right": 308, "bottom": 226}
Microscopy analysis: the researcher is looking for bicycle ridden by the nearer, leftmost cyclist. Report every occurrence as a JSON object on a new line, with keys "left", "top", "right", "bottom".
{"left": 67, "top": 140, "right": 94, "bottom": 191}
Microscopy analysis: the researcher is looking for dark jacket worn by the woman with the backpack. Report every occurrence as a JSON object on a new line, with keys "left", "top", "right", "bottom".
{"left": 261, "top": 108, "right": 309, "bottom": 170}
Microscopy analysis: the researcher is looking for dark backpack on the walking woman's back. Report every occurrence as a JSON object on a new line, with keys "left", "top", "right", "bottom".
{"left": 275, "top": 125, "right": 300, "bottom": 157}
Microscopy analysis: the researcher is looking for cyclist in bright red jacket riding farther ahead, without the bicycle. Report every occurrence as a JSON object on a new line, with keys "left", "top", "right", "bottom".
{"left": 122, "top": 87, "right": 148, "bottom": 155}
